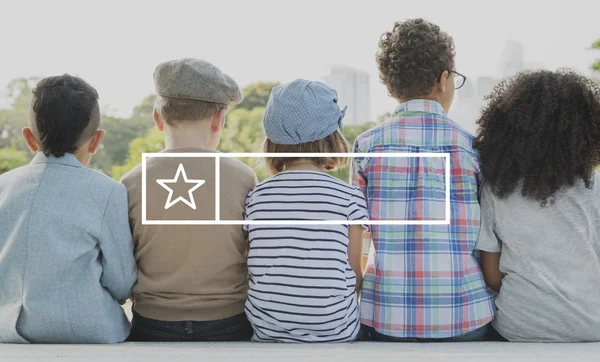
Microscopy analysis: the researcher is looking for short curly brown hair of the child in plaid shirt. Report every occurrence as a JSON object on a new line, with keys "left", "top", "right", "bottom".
{"left": 377, "top": 19, "right": 454, "bottom": 99}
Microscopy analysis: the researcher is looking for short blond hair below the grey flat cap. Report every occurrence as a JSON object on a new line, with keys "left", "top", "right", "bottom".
{"left": 154, "top": 96, "right": 228, "bottom": 126}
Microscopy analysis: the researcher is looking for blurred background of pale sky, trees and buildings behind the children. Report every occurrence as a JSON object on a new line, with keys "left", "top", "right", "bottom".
{"left": 0, "top": 0, "right": 600, "bottom": 180}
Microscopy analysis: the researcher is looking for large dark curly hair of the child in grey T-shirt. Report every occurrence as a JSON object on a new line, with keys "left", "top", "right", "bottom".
{"left": 474, "top": 70, "right": 600, "bottom": 206}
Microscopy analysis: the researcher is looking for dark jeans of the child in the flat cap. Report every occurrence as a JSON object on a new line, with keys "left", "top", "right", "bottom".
{"left": 127, "top": 311, "right": 253, "bottom": 342}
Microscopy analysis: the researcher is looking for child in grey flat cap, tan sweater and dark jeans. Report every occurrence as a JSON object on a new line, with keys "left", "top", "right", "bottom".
{"left": 122, "top": 59, "right": 257, "bottom": 341}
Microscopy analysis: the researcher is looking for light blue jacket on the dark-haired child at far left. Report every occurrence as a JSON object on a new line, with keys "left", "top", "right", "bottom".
{"left": 0, "top": 153, "right": 137, "bottom": 343}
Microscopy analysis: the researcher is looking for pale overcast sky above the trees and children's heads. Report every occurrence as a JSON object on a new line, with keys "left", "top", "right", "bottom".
{"left": 0, "top": 0, "right": 600, "bottom": 117}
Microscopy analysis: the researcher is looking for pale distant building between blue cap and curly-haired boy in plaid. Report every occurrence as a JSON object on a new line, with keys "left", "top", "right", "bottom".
{"left": 323, "top": 66, "right": 371, "bottom": 125}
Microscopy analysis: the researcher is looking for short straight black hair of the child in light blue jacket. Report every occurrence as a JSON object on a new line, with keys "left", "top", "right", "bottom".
{"left": 32, "top": 74, "right": 100, "bottom": 157}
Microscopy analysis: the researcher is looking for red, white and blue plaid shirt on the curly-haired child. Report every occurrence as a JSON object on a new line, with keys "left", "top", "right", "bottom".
{"left": 352, "top": 100, "right": 494, "bottom": 338}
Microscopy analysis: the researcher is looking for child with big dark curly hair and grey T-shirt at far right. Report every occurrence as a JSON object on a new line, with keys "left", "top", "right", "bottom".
{"left": 475, "top": 70, "right": 600, "bottom": 342}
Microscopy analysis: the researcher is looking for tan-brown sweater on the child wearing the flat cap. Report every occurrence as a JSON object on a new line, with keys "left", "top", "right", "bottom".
{"left": 121, "top": 148, "right": 257, "bottom": 321}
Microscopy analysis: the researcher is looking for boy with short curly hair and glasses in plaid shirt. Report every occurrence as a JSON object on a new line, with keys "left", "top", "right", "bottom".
{"left": 352, "top": 19, "right": 494, "bottom": 341}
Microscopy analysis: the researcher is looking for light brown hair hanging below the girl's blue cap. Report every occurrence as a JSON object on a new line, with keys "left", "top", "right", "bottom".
{"left": 263, "top": 129, "right": 350, "bottom": 174}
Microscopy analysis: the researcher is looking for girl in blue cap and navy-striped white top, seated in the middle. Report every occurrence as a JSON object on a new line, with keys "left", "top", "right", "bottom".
{"left": 245, "top": 80, "right": 367, "bottom": 342}
